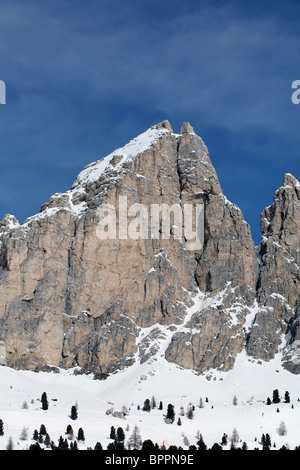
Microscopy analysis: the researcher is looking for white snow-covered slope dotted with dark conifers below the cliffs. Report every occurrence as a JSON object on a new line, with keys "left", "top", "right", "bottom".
{"left": 0, "top": 353, "right": 300, "bottom": 450}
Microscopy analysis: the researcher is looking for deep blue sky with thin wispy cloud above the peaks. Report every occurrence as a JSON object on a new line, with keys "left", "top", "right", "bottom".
{"left": 0, "top": 0, "right": 300, "bottom": 243}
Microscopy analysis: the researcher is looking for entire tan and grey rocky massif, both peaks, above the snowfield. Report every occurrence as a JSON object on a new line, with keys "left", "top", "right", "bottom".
{"left": 0, "top": 121, "right": 300, "bottom": 377}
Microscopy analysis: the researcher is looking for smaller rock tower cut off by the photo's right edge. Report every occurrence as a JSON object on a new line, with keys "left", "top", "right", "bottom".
{"left": 248, "top": 174, "right": 300, "bottom": 373}
